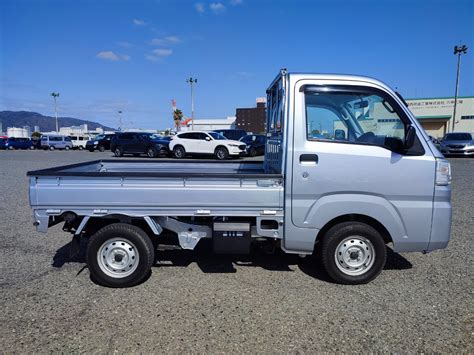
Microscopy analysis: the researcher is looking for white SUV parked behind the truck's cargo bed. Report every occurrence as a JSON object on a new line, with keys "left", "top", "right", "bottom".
{"left": 170, "top": 131, "right": 246, "bottom": 160}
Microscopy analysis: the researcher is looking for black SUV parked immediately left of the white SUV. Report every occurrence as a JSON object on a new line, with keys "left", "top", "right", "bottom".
{"left": 110, "top": 132, "right": 169, "bottom": 158}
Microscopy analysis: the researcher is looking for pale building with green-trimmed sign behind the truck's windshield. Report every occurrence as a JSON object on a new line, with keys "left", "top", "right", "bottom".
{"left": 406, "top": 96, "right": 474, "bottom": 138}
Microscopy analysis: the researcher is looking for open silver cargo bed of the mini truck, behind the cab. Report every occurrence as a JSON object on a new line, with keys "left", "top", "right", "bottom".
{"left": 28, "top": 160, "right": 284, "bottom": 221}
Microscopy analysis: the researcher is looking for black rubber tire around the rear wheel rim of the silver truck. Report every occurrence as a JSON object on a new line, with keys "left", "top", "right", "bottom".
{"left": 87, "top": 223, "right": 155, "bottom": 287}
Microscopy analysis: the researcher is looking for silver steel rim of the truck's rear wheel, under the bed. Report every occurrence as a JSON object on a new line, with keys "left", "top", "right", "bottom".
{"left": 97, "top": 238, "right": 139, "bottom": 278}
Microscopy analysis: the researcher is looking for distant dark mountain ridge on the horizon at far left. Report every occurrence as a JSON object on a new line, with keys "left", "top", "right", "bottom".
{"left": 0, "top": 111, "right": 114, "bottom": 132}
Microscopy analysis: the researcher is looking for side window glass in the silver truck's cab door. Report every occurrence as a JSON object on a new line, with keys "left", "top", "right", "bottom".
{"left": 305, "top": 89, "right": 405, "bottom": 149}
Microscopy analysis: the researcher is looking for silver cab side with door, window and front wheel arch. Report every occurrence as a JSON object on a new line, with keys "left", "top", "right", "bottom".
{"left": 291, "top": 80, "right": 435, "bottom": 251}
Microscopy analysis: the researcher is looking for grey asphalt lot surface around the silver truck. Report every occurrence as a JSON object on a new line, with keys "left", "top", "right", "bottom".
{"left": 0, "top": 151, "right": 474, "bottom": 353}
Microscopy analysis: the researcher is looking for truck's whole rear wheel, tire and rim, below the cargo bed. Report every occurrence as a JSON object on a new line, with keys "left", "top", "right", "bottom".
{"left": 87, "top": 223, "right": 155, "bottom": 287}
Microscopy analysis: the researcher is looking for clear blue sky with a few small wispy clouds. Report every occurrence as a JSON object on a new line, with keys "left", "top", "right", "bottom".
{"left": 0, "top": 0, "right": 474, "bottom": 128}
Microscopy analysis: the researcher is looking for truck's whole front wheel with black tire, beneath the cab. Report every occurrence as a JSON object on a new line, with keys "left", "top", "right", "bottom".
{"left": 320, "top": 222, "right": 387, "bottom": 285}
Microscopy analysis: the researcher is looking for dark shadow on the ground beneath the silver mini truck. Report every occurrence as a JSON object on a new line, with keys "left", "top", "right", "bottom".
{"left": 52, "top": 239, "right": 413, "bottom": 282}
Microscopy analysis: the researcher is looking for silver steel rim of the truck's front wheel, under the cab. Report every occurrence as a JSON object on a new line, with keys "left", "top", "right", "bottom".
{"left": 334, "top": 236, "right": 375, "bottom": 276}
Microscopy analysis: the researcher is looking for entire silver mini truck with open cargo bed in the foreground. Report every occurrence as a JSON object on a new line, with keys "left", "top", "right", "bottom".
{"left": 28, "top": 70, "right": 451, "bottom": 287}
